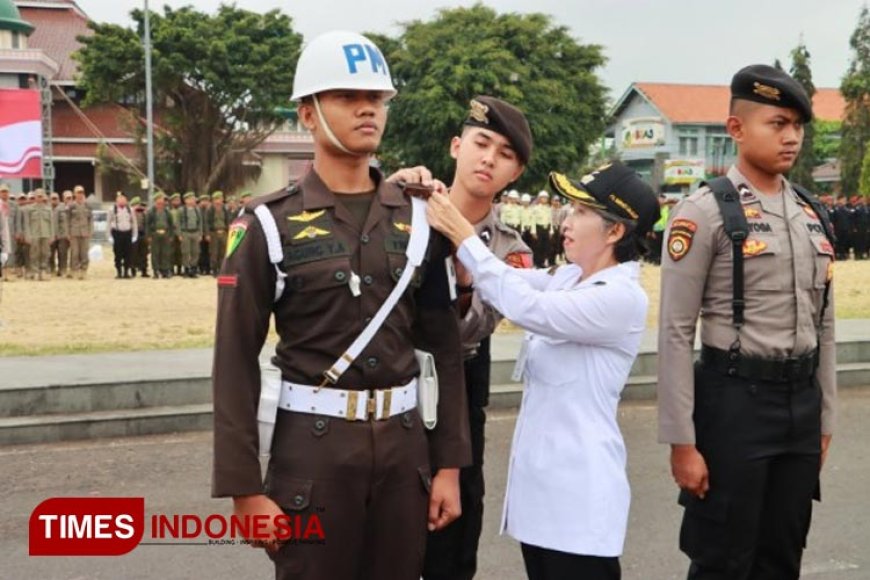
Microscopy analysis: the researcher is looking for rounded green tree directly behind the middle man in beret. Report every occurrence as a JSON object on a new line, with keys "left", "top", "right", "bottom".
{"left": 372, "top": 4, "right": 607, "bottom": 188}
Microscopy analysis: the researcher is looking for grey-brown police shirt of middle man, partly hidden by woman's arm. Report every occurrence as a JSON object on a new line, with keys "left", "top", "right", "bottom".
{"left": 459, "top": 206, "right": 532, "bottom": 358}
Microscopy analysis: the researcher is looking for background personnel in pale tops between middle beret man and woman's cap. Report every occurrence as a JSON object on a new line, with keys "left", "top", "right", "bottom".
{"left": 495, "top": 189, "right": 571, "bottom": 268}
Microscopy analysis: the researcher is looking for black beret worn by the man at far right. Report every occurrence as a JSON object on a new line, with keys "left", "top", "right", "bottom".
{"left": 731, "top": 64, "right": 813, "bottom": 123}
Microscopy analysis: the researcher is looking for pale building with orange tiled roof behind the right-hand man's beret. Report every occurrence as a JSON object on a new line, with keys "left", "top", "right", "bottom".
{"left": 608, "top": 82, "right": 846, "bottom": 191}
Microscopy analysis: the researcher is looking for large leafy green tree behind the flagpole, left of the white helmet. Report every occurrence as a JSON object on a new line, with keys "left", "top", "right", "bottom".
{"left": 75, "top": 5, "right": 302, "bottom": 192}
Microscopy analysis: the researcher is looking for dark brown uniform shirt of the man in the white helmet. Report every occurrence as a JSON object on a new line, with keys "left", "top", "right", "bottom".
{"left": 212, "top": 171, "right": 471, "bottom": 497}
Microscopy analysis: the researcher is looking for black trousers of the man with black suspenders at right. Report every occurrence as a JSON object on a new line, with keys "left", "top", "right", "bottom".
{"left": 680, "top": 364, "right": 821, "bottom": 580}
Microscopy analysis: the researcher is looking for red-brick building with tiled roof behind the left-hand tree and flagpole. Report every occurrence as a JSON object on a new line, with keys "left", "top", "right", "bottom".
{"left": 0, "top": 0, "right": 314, "bottom": 201}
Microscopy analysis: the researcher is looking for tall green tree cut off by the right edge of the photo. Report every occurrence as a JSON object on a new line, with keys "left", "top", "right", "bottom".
{"left": 840, "top": 5, "right": 870, "bottom": 195}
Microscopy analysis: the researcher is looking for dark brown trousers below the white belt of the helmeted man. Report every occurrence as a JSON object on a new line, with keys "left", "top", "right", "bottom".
{"left": 266, "top": 410, "right": 432, "bottom": 580}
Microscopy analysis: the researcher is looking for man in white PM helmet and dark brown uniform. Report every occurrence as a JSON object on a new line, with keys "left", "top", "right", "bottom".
{"left": 212, "top": 32, "right": 471, "bottom": 580}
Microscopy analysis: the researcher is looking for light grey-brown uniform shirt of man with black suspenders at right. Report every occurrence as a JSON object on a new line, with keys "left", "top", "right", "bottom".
{"left": 658, "top": 167, "right": 837, "bottom": 444}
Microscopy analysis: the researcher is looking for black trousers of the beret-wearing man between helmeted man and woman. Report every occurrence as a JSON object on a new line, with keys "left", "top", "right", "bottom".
{"left": 423, "top": 338, "right": 490, "bottom": 580}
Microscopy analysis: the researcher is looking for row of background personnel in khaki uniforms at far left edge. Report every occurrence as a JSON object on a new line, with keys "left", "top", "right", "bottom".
{"left": 0, "top": 184, "right": 94, "bottom": 281}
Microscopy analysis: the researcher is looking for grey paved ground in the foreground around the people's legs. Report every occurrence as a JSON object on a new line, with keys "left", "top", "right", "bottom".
{"left": 0, "top": 389, "right": 870, "bottom": 580}
